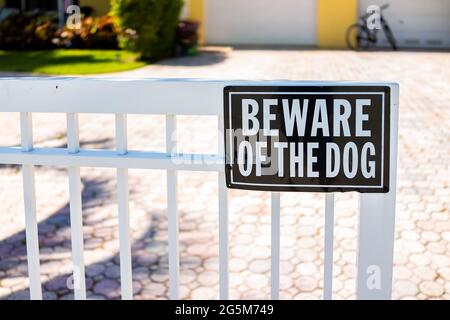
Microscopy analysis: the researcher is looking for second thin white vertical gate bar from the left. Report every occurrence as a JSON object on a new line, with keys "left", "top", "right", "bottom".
{"left": 67, "top": 113, "right": 86, "bottom": 300}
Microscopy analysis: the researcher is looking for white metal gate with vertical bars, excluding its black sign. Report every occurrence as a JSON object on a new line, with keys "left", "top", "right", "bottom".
{"left": 0, "top": 78, "right": 398, "bottom": 299}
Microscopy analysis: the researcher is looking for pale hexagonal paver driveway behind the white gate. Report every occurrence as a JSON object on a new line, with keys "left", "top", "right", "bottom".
{"left": 0, "top": 50, "right": 450, "bottom": 299}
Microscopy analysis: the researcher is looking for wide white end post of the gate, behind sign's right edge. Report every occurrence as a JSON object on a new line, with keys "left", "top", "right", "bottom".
{"left": 356, "top": 85, "right": 399, "bottom": 300}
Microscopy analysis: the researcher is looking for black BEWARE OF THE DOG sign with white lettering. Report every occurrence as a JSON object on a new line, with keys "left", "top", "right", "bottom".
{"left": 224, "top": 86, "right": 390, "bottom": 193}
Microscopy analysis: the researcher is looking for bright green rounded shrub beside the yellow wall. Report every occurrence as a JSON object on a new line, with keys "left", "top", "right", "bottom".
{"left": 112, "top": 0, "right": 183, "bottom": 60}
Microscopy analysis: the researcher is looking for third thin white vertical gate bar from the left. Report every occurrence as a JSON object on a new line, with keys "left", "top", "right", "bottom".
{"left": 116, "top": 114, "right": 133, "bottom": 300}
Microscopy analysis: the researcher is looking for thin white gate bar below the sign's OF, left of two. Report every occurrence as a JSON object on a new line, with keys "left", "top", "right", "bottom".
{"left": 271, "top": 192, "right": 280, "bottom": 300}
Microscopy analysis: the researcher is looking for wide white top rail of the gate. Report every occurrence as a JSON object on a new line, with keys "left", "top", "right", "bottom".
{"left": 0, "top": 78, "right": 395, "bottom": 116}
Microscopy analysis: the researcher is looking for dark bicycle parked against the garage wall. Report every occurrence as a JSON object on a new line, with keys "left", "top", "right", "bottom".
{"left": 345, "top": 4, "right": 398, "bottom": 51}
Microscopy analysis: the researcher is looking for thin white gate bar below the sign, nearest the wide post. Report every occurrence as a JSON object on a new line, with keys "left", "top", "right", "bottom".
{"left": 323, "top": 193, "right": 334, "bottom": 300}
